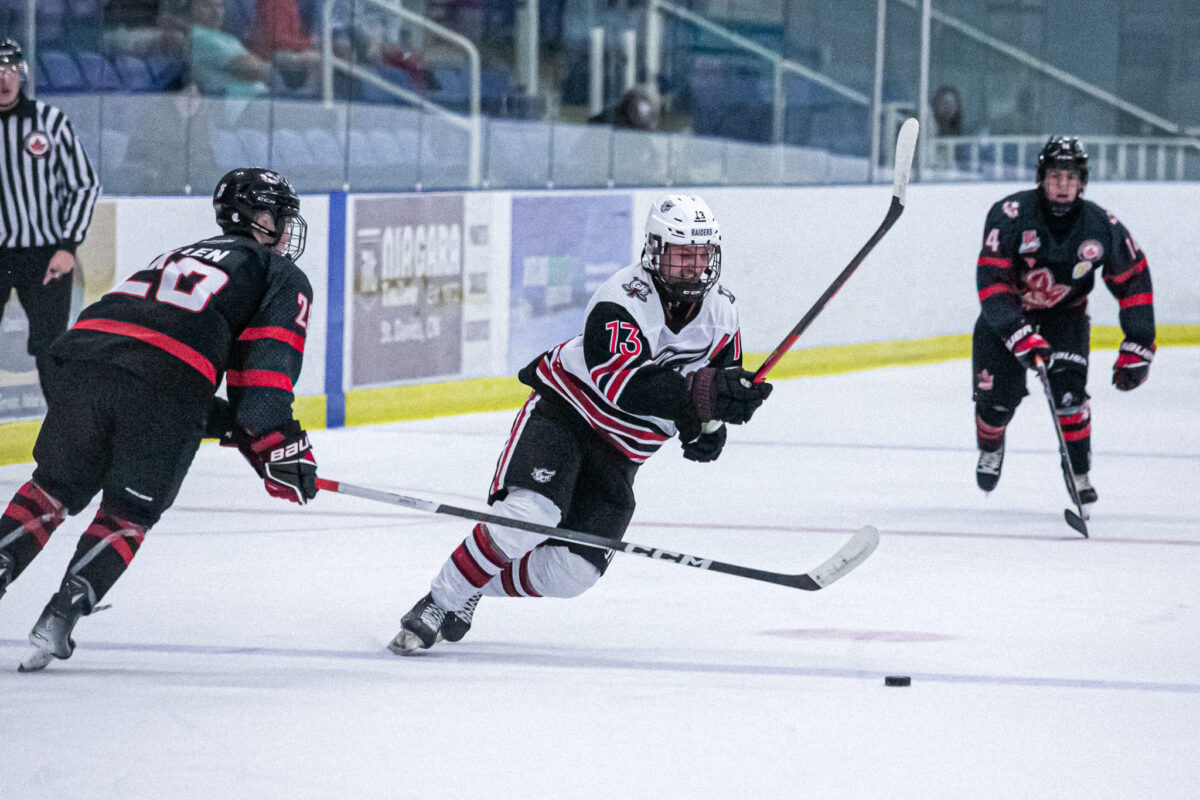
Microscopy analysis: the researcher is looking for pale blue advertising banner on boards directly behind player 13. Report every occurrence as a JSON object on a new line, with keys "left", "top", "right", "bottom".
{"left": 509, "top": 192, "right": 632, "bottom": 372}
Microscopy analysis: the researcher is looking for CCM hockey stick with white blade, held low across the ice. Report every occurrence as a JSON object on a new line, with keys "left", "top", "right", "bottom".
{"left": 317, "top": 477, "right": 880, "bottom": 591}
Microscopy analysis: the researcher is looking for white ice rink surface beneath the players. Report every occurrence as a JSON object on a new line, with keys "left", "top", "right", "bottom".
{"left": 0, "top": 348, "right": 1200, "bottom": 800}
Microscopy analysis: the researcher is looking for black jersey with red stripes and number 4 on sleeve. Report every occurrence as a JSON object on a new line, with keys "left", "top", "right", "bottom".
{"left": 976, "top": 188, "right": 1154, "bottom": 348}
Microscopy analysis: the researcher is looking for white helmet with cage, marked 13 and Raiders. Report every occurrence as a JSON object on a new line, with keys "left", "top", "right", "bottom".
{"left": 642, "top": 194, "right": 721, "bottom": 301}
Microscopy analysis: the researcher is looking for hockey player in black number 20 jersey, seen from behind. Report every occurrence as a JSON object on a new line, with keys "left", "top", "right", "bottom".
{"left": 0, "top": 169, "right": 317, "bottom": 672}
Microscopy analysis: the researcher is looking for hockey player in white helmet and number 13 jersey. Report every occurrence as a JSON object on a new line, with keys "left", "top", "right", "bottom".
{"left": 389, "top": 194, "right": 772, "bottom": 655}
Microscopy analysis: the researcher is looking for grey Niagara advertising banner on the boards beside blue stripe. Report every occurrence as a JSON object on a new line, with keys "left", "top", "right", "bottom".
{"left": 349, "top": 194, "right": 463, "bottom": 387}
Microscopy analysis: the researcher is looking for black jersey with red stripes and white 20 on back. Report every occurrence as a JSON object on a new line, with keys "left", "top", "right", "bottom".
{"left": 53, "top": 235, "right": 312, "bottom": 434}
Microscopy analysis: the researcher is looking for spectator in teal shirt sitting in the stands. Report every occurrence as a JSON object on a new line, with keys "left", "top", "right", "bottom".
{"left": 191, "top": 0, "right": 270, "bottom": 97}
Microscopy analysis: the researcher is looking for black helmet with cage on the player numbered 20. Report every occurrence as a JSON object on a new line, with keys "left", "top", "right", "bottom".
{"left": 212, "top": 167, "right": 308, "bottom": 260}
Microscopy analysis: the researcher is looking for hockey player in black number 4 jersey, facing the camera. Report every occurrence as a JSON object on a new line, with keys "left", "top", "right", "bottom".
{"left": 972, "top": 137, "right": 1156, "bottom": 504}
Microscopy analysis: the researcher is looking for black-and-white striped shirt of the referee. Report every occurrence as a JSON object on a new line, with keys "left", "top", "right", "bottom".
{"left": 0, "top": 92, "right": 100, "bottom": 253}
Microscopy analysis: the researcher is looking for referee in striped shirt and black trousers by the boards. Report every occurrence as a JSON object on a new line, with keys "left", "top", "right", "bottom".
{"left": 0, "top": 38, "right": 100, "bottom": 393}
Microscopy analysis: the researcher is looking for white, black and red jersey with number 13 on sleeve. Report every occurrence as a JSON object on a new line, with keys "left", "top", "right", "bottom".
{"left": 520, "top": 264, "right": 742, "bottom": 463}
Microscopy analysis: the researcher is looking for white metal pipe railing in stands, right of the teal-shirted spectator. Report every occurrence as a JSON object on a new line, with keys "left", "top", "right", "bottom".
{"left": 320, "top": 0, "right": 482, "bottom": 188}
